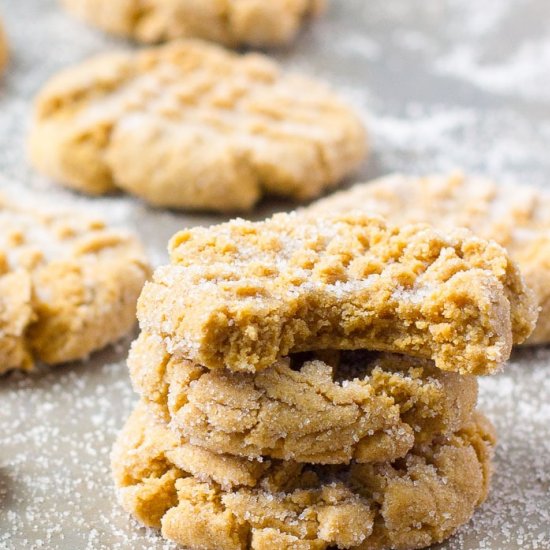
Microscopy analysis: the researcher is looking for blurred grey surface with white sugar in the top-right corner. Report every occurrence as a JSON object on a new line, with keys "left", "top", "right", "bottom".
{"left": 286, "top": 0, "right": 550, "bottom": 190}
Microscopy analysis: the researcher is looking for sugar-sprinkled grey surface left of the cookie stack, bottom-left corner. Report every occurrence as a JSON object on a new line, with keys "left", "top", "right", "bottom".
{"left": 0, "top": 341, "right": 173, "bottom": 550}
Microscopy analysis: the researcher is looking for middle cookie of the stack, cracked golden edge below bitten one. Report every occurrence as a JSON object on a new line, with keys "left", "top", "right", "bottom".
{"left": 128, "top": 333, "right": 477, "bottom": 464}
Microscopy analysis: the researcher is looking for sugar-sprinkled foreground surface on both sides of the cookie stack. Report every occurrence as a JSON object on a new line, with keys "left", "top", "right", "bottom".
{"left": 0, "top": 341, "right": 550, "bottom": 550}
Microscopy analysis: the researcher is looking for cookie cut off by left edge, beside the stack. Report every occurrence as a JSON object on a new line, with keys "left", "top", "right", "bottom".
{"left": 0, "top": 196, "right": 149, "bottom": 372}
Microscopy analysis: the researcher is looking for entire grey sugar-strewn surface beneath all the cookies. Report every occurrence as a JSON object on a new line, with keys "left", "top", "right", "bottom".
{"left": 0, "top": 0, "right": 550, "bottom": 550}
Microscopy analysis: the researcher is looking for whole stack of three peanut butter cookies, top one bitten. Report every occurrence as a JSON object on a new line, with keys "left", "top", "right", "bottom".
{"left": 112, "top": 214, "right": 537, "bottom": 550}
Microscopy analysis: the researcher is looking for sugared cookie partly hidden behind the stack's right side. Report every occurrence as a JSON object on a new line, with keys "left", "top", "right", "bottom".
{"left": 307, "top": 173, "right": 550, "bottom": 344}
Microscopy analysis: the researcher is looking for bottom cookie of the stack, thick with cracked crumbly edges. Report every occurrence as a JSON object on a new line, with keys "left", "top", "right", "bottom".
{"left": 112, "top": 406, "right": 495, "bottom": 550}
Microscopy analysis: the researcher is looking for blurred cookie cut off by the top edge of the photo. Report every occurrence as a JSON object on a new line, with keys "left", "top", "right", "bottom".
{"left": 62, "top": 0, "right": 325, "bottom": 46}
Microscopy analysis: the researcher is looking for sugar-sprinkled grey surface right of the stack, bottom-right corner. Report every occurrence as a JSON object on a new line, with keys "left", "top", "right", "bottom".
{"left": 446, "top": 349, "right": 550, "bottom": 550}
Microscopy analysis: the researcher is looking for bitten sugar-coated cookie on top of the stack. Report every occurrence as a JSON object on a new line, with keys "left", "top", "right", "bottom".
{"left": 138, "top": 214, "right": 537, "bottom": 374}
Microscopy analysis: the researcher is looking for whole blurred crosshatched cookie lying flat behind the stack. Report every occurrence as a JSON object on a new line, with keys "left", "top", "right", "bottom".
{"left": 30, "top": 40, "right": 367, "bottom": 211}
